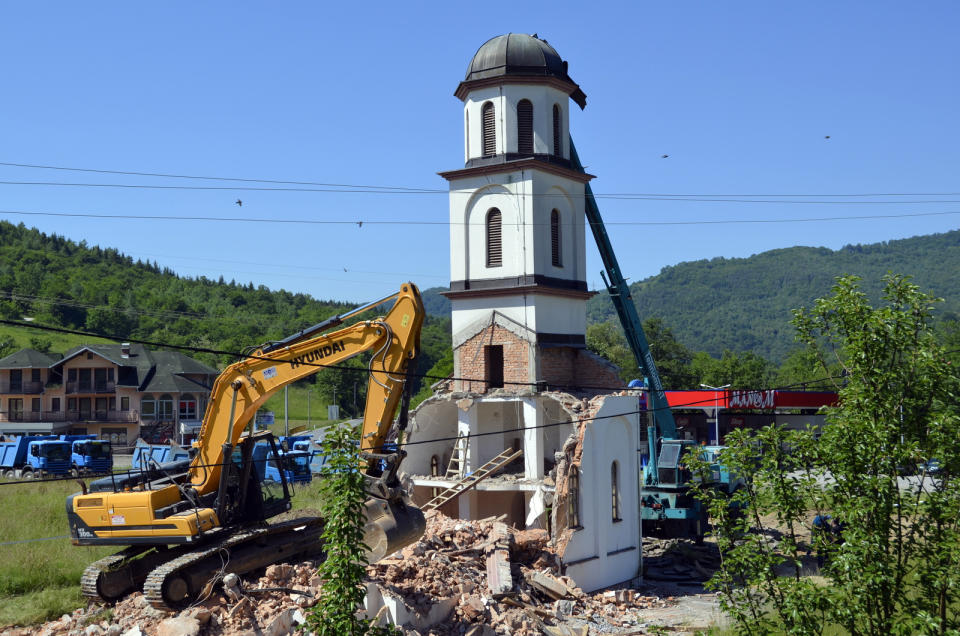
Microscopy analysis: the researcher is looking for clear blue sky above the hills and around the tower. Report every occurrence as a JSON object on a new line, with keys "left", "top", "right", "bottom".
{"left": 0, "top": 1, "right": 960, "bottom": 301}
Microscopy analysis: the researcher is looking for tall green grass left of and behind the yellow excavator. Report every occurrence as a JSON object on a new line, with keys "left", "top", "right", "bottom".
{"left": 0, "top": 468, "right": 330, "bottom": 631}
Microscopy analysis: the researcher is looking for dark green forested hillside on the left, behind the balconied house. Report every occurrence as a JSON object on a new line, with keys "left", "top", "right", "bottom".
{"left": 0, "top": 221, "right": 450, "bottom": 408}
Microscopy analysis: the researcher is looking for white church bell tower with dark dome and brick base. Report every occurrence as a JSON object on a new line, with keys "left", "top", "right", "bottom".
{"left": 440, "top": 33, "right": 608, "bottom": 392}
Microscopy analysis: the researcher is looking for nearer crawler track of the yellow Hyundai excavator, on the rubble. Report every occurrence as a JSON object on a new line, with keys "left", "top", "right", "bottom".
{"left": 143, "top": 517, "right": 323, "bottom": 611}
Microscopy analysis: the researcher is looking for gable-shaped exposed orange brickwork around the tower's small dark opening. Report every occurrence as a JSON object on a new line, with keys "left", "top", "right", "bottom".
{"left": 454, "top": 324, "right": 533, "bottom": 393}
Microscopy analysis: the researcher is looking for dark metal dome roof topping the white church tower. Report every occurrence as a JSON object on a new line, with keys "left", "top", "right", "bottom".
{"left": 456, "top": 33, "right": 587, "bottom": 108}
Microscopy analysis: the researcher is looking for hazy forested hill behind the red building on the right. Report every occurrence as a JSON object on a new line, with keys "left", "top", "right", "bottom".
{"left": 587, "top": 231, "right": 960, "bottom": 362}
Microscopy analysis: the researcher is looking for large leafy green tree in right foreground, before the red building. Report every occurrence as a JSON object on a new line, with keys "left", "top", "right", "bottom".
{"left": 691, "top": 274, "right": 960, "bottom": 635}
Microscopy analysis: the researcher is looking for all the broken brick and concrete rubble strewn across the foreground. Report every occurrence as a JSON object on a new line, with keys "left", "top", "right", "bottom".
{"left": 24, "top": 512, "right": 688, "bottom": 636}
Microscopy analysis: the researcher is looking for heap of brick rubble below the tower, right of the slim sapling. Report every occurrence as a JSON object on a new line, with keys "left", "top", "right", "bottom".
{"left": 367, "top": 512, "right": 673, "bottom": 636}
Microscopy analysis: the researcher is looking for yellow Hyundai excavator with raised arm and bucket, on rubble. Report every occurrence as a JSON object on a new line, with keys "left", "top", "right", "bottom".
{"left": 66, "top": 283, "right": 425, "bottom": 609}
